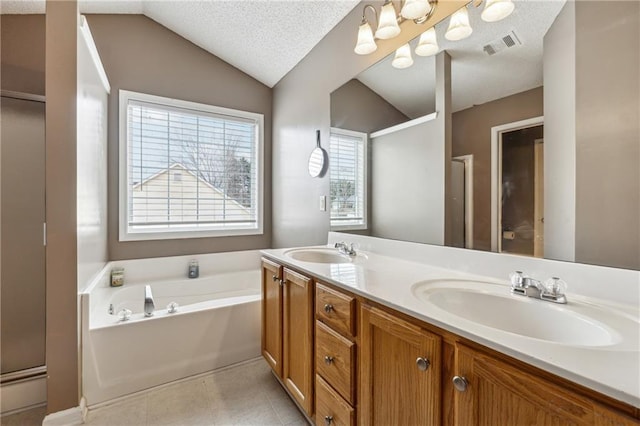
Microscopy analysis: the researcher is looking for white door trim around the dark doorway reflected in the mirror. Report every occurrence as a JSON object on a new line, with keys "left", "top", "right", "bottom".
{"left": 491, "top": 115, "right": 544, "bottom": 252}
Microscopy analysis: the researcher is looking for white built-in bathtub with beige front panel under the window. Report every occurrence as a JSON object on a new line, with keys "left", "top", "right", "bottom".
{"left": 80, "top": 251, "right": 260, "bottom": 407}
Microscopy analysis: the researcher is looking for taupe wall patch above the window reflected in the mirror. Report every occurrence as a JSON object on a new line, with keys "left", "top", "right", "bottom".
{"left": 331, "top": 78, "right": 409, "bottom": 133}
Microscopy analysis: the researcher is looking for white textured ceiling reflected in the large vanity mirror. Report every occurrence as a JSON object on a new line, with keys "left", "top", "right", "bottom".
{"left": 357, "top": 0, "right": 565, "bottom": 118}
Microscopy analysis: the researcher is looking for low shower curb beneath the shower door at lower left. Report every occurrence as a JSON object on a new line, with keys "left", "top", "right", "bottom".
{"left": 0, "top": 376, "right": 47, "bottom": 415}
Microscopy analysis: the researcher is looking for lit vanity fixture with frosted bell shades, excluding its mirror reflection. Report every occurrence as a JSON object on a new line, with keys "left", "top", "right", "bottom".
{"left": 353, "top": 0, "right": 438, "bottom": 55}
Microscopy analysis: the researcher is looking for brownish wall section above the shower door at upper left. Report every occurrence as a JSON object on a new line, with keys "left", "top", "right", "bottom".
{"left": 0, "top": 15, "right": 45, "bottom": 95}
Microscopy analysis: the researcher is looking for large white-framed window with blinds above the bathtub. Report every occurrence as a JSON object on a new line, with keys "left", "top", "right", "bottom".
{"left": 120, "top": 90, "right": 264, "bottom": 241}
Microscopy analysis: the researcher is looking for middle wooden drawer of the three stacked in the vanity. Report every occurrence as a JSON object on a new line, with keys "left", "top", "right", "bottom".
{"left": 316, "top": 321, "right": 356, "bottom": 404}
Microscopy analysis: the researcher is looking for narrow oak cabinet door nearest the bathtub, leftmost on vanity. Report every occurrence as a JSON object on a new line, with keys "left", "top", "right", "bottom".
{"left": 262, "top": 259, "right": 282, "bottom": 377}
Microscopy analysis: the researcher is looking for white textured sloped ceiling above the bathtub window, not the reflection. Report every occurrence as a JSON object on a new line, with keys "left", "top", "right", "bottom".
{"left": 0, "top": 0, "right": 359, "bottom": 87}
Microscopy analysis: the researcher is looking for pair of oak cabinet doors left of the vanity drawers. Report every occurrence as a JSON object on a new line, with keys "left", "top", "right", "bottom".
{"left": 262, "top": 259, "right": 314, "bottom": 416}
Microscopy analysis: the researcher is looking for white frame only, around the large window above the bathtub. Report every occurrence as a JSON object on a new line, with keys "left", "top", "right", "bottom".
{"left": 118, "top": 89, "right": 264, "bottom": 241}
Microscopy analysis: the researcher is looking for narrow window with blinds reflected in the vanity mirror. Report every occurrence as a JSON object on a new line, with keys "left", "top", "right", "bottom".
{"left": 329, "top": 128, "right": 367, "bottom": 229}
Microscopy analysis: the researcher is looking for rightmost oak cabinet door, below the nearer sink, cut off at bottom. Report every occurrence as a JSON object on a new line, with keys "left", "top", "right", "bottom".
{"left": 445, "top": 345, "right": 596, "bottom": 425}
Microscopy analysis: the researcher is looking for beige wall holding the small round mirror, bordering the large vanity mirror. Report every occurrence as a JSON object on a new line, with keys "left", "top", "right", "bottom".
{"left": 273, "top": 1, "right": 465, "bottom": 247}
